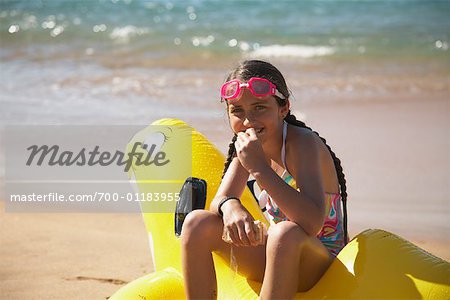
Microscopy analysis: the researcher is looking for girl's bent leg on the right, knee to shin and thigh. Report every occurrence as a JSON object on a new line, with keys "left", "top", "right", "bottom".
{"left": 260, "top": 221, "right": 333, "bottom": 299}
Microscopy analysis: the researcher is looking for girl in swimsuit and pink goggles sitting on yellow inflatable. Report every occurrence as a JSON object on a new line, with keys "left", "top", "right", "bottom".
{"left": 181, "top": 60, "right": 348, "bottom": 299}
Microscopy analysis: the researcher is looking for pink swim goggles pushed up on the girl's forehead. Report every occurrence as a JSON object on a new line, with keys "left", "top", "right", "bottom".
{"left": 220, "top": 77, "right": 284, "bottom": 100}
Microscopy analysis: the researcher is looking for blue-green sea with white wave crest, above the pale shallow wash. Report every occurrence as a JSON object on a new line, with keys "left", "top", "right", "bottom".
{"left": 0, "top": 0, "right": 450, "bottom": 61}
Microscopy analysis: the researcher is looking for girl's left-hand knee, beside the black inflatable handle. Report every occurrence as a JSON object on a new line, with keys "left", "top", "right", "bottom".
{"left": 181, "top": 209, "right": 221, "bottom": 244}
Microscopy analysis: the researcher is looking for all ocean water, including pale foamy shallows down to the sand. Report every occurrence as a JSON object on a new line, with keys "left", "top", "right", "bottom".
{"left": 0, "top": 0, "right": 450, "bottom": 125}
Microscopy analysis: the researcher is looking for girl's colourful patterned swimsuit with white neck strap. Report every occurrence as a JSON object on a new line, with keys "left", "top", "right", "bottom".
{"left": 258, "top": 122, "right": 348, "bottom": 256}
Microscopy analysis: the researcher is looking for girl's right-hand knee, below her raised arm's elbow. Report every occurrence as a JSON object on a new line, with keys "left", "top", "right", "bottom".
{"left": 267, "top": 221, "right": 309, "bottom": 250}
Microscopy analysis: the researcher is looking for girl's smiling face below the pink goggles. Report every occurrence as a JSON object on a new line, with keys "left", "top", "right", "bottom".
{"left": 228, "top": 89, "right": 289, "bottom": 146}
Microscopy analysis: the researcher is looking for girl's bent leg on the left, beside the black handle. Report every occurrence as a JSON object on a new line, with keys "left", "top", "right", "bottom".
{"left": 181, "top": 210, "right": 265, "bottom": 299}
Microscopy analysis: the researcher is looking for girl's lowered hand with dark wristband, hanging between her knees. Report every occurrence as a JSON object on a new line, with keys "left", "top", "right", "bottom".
{"left": 222, "top": 200, "right": 258, "bottom": 247}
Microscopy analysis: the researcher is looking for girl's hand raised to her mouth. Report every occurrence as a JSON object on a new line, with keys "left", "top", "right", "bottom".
{"left": 234, "top": 128, "right": 267, "bottom": 174}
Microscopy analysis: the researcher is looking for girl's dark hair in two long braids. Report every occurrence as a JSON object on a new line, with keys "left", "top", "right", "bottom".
{"left": 222, "top": 60, "right": 348, "bottom": 243}
